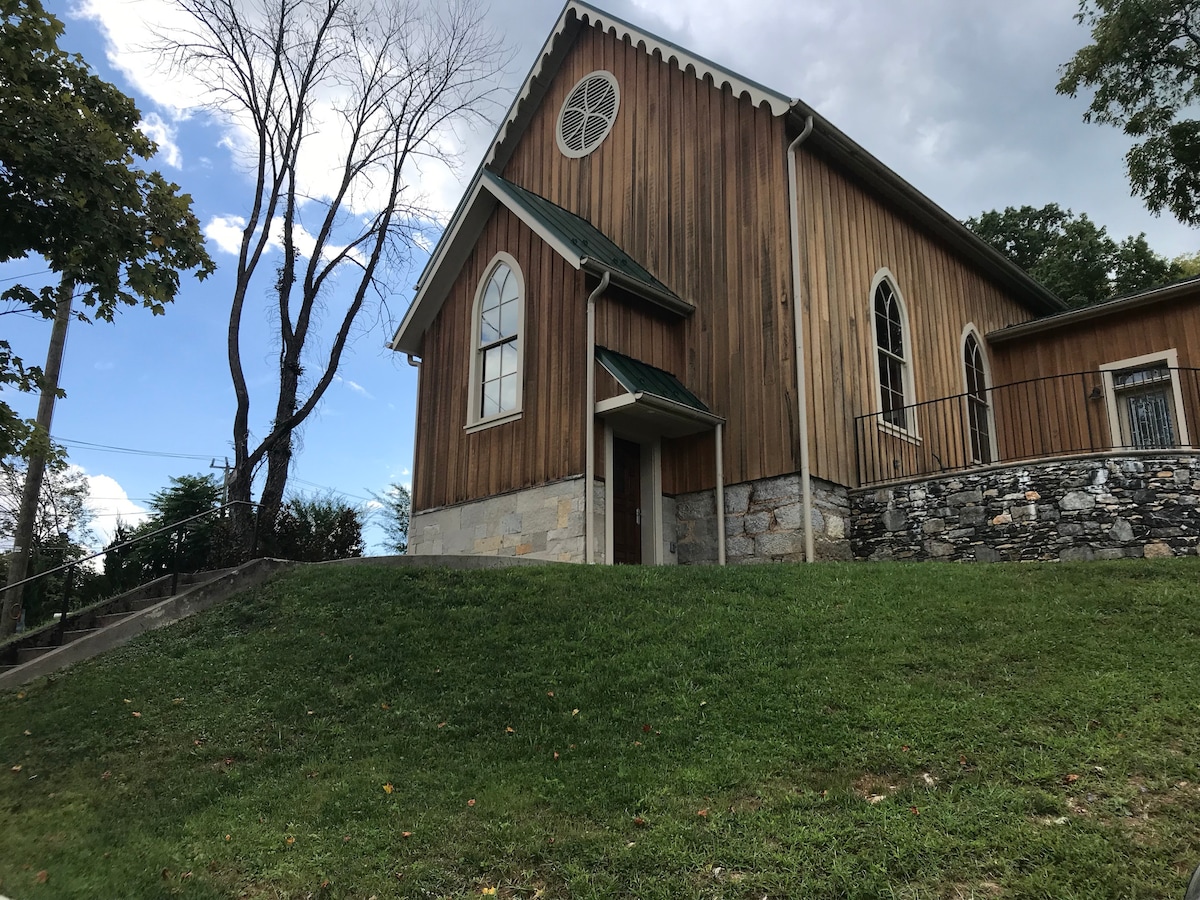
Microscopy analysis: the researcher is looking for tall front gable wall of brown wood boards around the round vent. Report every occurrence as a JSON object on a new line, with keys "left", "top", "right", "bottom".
{"left": 502, "top": 22, "right": 799, "bottom": 493}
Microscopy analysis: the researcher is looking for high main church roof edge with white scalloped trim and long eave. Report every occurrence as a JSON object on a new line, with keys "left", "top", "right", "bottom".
{"left": 389, "top": 0, "right": 1067, "bottom": 353}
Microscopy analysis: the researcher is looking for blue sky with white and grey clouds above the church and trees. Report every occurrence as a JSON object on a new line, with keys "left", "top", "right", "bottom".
{"left": 0, "top": 0, "right": 1200, "bottom": 551}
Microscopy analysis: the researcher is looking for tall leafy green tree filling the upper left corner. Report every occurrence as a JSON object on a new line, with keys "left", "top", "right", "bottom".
{"left": 0, "top": 0, "right": 212, "bottom": 637}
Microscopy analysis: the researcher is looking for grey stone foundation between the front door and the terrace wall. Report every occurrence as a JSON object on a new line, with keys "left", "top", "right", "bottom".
{"left": 676, "top": 474, "right": 851, "bottom": 564}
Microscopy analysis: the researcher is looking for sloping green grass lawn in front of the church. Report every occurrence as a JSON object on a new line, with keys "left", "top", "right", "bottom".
{"left": 0, "top": 559, "right": 1200, "bottom": 900}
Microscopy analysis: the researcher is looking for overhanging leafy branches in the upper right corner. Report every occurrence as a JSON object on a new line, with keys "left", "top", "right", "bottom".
{"left": 1057, "top": 0, "right": 1200, "bottom": 224}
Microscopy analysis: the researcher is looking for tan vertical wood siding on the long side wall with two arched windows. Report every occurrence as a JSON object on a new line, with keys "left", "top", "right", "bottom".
{"left": 798, "top": 146, "right": 1033, "bottom": 487}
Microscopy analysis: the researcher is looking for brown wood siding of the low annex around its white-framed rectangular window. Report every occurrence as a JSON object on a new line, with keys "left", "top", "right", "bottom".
{"left": 991, "top": 296, "right": 1200, "bottom": 457}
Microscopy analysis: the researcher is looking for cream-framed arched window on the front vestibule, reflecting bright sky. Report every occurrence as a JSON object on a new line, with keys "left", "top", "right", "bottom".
{"left": 467, "top": 253, "right": 524, "bottom": 427}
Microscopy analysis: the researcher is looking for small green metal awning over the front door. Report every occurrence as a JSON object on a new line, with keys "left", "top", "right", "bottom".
{"left": 596, "top": 346, "right": 725, "bottom": 438}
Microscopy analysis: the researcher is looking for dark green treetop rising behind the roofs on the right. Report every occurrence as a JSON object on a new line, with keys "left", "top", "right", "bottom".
{"left": 965, "top": 203, "right": 1182, "bottom": 306}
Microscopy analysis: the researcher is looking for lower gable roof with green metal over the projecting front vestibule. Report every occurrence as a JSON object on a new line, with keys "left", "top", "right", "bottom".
{"left": 389, "top": 169, "right": 696, "bottom": 353}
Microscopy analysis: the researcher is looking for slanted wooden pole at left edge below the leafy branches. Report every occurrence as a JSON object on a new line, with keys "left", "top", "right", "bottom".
{"left": 0, "top": 275, "right": 76, "bottom": 638}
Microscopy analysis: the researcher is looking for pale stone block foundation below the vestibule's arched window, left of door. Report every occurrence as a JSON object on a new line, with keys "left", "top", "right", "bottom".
{"left": 408, "top": 478, "right": 604, "bottom": 563}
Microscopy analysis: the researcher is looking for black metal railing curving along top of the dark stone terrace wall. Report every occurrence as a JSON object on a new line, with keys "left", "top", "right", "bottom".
{"left": 854, "top": 366, "right": 1200, "bottom": 486}
